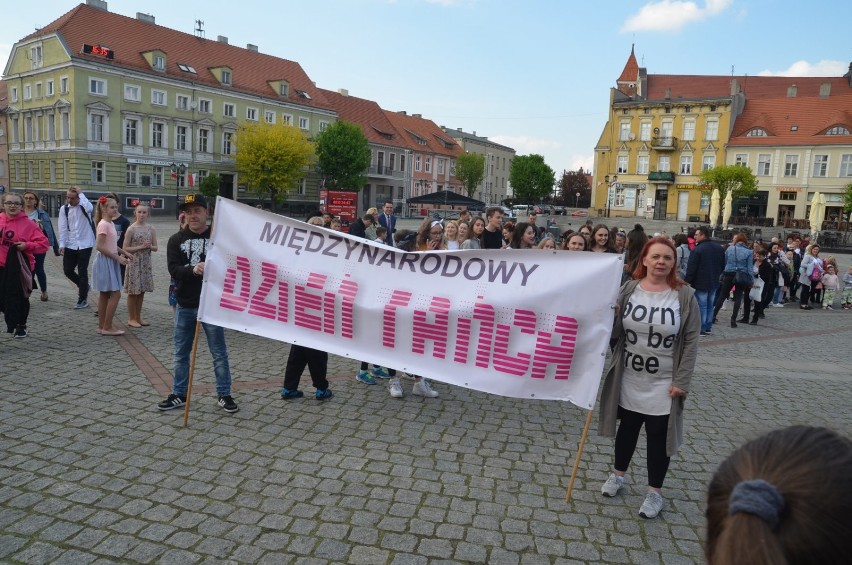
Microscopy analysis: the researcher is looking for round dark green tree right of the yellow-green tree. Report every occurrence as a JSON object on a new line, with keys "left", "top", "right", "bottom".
{"left": 316, "top": 121, "right": 372, "bottom": 190}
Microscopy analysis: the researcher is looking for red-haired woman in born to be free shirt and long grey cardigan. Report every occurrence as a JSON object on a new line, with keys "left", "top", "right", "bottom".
{"left": 598, "top": 237, "right": 701, "bottom": 518}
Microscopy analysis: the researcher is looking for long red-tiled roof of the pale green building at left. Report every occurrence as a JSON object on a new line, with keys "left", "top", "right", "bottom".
{"left": 22, "top": 4, "right": 331, "bottom": 109}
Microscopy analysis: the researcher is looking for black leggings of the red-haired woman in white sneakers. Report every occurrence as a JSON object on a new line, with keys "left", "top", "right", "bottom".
{"left": 615, "top": 406, "right": 671, "bottom": 488}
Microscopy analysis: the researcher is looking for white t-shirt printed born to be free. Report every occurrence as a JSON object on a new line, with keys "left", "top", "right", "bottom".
{"left": 619, "top": 285, "right": 680, "bottom": 416}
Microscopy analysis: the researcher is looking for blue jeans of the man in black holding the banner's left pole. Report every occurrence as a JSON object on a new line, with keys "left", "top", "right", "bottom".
{"left": 172, "top": 305, "right": 231, "bottom": 396}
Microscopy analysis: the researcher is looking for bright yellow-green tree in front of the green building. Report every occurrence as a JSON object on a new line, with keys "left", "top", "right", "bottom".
{"left": 234, "top": 122, "right": 315, "bottom": 209}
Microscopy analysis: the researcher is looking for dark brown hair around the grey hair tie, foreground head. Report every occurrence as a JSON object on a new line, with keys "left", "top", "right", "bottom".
{"left": 704, "top": 426, "right": 852, "bottom": 565}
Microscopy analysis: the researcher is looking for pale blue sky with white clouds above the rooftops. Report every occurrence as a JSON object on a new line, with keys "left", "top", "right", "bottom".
{"left": 0, "top": 0, "right": 852, "bottom": 177}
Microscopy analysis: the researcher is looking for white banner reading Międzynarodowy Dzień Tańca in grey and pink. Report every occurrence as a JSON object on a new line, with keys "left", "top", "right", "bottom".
{"left": 198, "top": 197, "right": 622, "bottom": 409}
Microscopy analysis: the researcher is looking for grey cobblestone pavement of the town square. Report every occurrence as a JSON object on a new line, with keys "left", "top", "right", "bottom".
{"left": 0, "top": 215, "right": 852, "bottom": 565}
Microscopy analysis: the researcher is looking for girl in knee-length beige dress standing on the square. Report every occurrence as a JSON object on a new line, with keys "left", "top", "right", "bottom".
{"left": 124, "top": 204, "right": 157, "bottom": 328}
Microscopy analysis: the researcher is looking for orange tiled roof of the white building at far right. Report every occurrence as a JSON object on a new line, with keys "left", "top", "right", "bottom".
{"left": 729, "top": 93, "right": 852, "bottom": 146}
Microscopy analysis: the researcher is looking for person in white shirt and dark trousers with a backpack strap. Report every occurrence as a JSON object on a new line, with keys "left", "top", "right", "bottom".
{"left": 59, "top": 186, "right": 95, "bottom": 310}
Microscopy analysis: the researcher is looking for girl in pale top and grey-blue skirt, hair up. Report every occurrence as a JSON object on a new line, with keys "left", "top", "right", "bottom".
{"left": 92, "top": 196, "right": 132, "bottom": 335}
